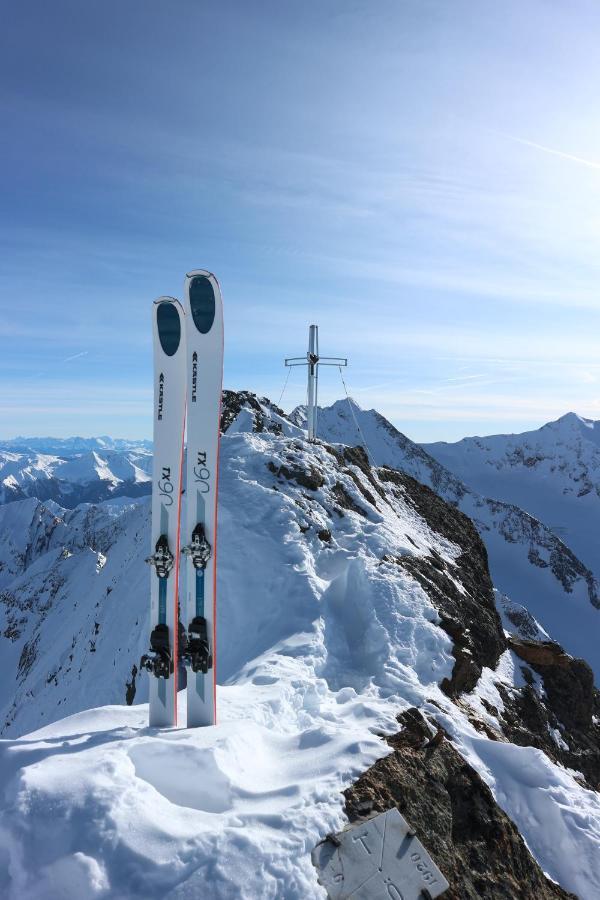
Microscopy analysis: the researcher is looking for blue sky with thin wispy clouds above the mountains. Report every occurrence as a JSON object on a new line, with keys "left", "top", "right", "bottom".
{"left": 0, "top": 0, "right": 600, "bottom": 441}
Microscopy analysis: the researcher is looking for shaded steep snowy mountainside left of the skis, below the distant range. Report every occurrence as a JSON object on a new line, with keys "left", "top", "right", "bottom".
{"left": 0, "top": 499, "right": 149, "bottom": 734}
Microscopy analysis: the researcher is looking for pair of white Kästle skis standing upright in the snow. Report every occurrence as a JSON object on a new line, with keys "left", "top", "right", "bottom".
{"left": 140, "top": 270, "right": 223, "bottom": 728}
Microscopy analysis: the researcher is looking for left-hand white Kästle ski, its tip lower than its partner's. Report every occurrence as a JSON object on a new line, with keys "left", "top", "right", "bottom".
{"left": 141, "top": 297, "right": 185, "bottom": 727}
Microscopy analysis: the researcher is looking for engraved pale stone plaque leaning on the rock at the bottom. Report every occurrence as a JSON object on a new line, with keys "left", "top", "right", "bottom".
{"left": 312, "top": 809, "right": 449, "bottom": 900}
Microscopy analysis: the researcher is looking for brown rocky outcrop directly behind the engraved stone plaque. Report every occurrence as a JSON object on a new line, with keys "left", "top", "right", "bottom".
{"left": 344, "top": 709, "right": 574, "bottom": 900}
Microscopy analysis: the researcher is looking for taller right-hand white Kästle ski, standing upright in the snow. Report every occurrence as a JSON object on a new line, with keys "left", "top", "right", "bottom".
{"left": 181, "top": 269, "right": 223, "bottom": 728}
